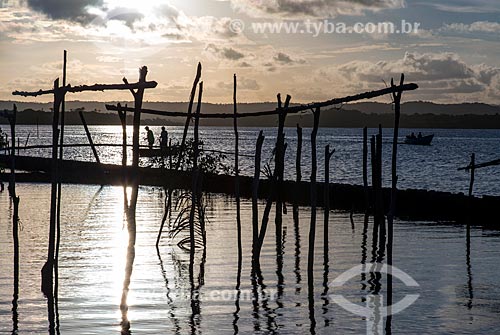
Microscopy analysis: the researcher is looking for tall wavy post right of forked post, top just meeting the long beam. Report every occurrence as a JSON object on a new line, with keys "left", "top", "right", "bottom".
{"left": 307, "top": 107, "right": 321, "bottom": 330}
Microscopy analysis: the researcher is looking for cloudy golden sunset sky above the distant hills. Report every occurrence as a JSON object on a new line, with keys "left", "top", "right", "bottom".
{"left": 0, "top": 0, "right": 500, "bottom": 104}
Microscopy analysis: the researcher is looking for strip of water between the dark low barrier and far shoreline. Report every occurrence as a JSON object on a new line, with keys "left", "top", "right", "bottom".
{"left": 3, "top": 125, "right": 500, "bottom": 195}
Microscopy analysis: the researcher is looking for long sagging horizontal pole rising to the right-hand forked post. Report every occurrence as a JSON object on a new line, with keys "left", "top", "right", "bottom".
{"left": 106, "top": 84, "right": 418, "bottom": 119}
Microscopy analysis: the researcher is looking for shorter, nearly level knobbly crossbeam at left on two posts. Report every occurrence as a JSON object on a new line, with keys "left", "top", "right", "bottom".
{"left": 12, "top": 81, "right": 158, "bottom": 97}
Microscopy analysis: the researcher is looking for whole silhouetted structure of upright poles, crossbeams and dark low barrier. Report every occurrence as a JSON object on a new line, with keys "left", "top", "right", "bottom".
{"left": 13, "top": 52, "right": 500, "bottom": 332}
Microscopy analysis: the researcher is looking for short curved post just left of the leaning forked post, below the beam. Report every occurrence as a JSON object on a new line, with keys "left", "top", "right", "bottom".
{"left": 252, "top": 130, "right": 265, "bottom": 263}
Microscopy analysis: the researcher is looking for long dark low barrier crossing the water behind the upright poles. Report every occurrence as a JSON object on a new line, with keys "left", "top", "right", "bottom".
{"left": 0, "top": 155, "right": 500, "bottom": 229}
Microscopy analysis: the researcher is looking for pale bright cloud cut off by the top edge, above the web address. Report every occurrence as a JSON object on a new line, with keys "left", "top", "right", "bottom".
{"left": 230, "top": 0, "right": 405, "bottom": 19}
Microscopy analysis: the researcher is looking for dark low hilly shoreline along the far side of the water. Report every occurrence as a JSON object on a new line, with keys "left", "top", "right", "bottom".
{"left": 0, "top": 109, "right": 500, "bottom": 129}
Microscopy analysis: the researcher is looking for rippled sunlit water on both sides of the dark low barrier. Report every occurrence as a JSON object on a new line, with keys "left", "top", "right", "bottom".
{"left": 0, "top": 127, "right": 500, "bottom": 334}
